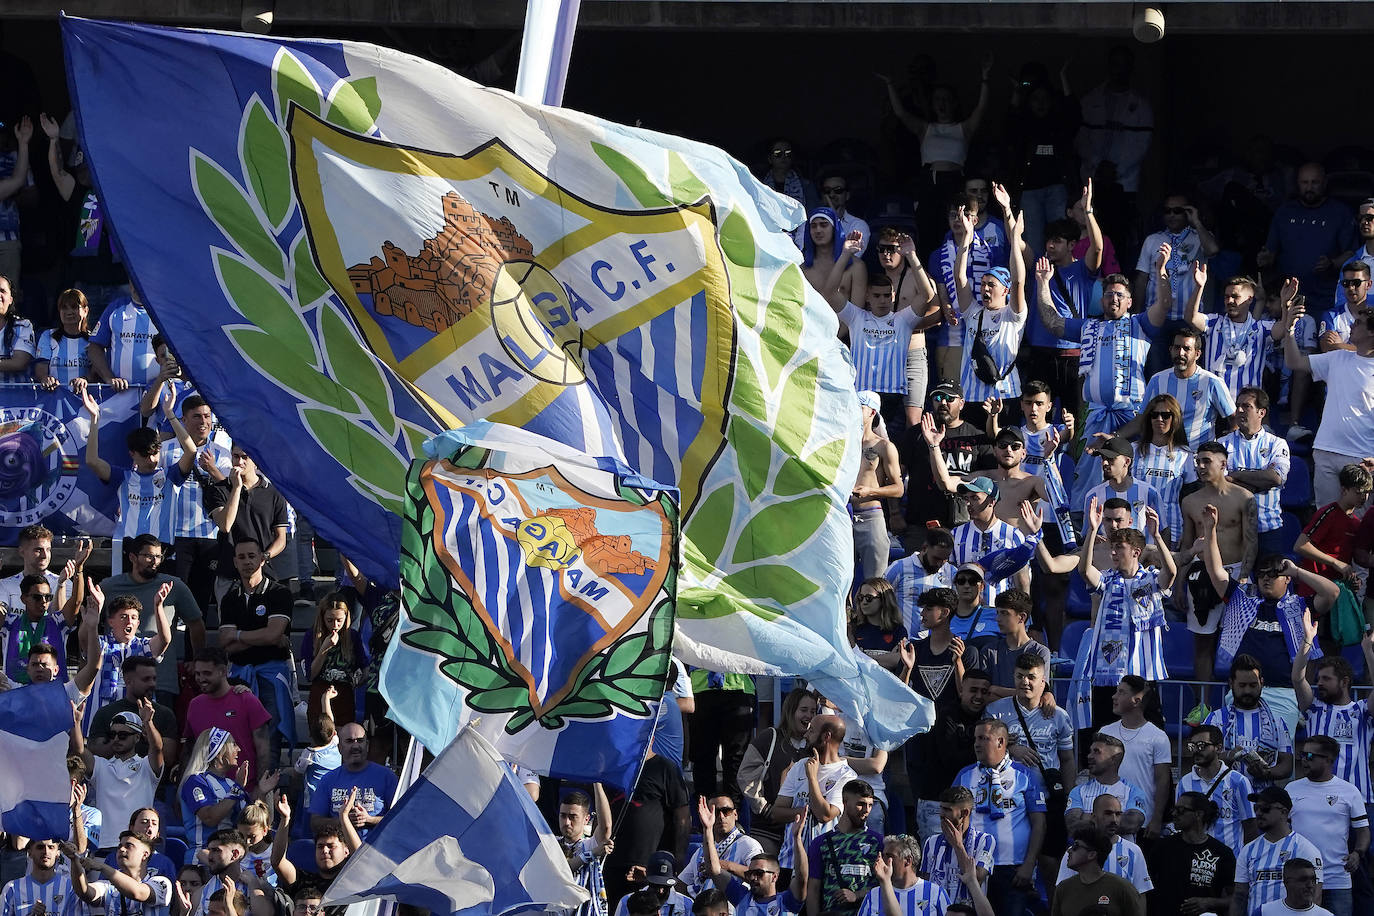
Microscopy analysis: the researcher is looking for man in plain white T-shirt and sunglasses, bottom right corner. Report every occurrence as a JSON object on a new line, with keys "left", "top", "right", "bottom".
{"left": 1286, "top": 735, "right": 1370, "bottom": 916}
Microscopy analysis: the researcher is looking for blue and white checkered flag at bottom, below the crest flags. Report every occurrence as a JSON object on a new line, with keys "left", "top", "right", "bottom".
{"left": 324, "top": 726, "right": 588, "bottom": 916}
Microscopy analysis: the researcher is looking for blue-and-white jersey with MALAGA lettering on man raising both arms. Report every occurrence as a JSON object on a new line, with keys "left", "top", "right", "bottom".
{"left": 1092, "top": 566, "right": 1169, "bottom": 687}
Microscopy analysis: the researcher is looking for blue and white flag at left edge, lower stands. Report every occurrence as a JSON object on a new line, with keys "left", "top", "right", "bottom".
{"left": 0, "top": 681, "right": 71, "bottom": 839}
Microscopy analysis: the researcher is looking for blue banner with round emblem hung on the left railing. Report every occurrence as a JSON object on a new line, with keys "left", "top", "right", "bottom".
{"left": 0, "top": 385, "right": 143, "bottom": 545}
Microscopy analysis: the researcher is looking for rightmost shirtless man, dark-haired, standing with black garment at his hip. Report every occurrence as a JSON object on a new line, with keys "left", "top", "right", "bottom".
{"left": 1178, "top": 442, "right": 1260, "bottom": 681}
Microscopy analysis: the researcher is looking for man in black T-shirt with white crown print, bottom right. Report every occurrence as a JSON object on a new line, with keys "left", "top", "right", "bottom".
{"left": 1146, "top": 792, "right": 1235, "bottom": 916}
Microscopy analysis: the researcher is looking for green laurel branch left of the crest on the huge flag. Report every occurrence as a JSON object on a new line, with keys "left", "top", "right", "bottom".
{"left": 191, "top": 48, "right": 425, "bottom": 515}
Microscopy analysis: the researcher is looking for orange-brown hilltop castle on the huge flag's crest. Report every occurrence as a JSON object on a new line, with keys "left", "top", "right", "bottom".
{"left": 348, "top": 191, "right": 534, "bottom": 334}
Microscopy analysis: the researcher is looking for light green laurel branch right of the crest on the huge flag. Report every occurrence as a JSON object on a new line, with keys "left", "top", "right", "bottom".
{"left": 592, "top": 143, "right": 852, "bottom": 619}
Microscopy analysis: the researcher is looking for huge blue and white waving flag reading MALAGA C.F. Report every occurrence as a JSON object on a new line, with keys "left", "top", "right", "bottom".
{"left": 63, "top": 18, "right": 915, "bottom": 746}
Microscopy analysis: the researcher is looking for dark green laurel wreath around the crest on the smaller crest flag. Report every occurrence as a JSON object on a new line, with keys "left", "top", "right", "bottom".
{"left": 401, "top": 448, "right": 677, "bottom": 735}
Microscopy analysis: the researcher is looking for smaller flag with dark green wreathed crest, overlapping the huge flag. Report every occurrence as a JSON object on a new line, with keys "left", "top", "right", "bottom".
{"left": 381, "top": 422, "right": 679, "bottom": 791}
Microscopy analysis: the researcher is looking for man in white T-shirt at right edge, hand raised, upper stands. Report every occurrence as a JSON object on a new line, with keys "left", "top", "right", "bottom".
{"left": 1283, "top": 289, "right": 1374, "bottom": 505}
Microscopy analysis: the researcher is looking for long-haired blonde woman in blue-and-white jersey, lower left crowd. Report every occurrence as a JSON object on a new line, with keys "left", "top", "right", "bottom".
{"left": 177, "top": 728, "right": 280, "bottom": 850}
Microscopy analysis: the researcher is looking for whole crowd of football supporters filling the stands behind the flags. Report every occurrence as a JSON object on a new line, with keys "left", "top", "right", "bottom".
{"left": 0, "top": 42, "right": 1374, "bottom": 916}
